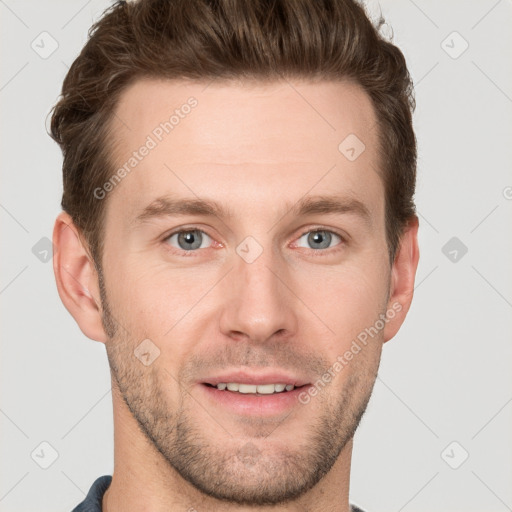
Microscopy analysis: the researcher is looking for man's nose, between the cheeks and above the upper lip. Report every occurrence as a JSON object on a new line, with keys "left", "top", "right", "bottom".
{"left": 220, "top": 244, "right": 298, "bottom": 343}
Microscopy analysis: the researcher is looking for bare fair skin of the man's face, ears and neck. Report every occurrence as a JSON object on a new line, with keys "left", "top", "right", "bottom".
{"left": 53, "top": 80, "right": 419, "bottom": 512}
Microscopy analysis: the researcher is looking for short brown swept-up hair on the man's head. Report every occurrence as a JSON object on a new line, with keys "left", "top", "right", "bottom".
{"left": 51, "top": 0, "right": 416, "bottom": 270}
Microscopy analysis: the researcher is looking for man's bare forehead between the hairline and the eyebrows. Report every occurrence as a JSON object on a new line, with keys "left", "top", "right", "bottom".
{"left": 106, "top": 79, "right": 383, "bottom": 223}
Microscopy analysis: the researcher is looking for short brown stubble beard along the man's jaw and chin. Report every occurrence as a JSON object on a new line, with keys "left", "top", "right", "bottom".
{"left": 99, "top": 270, "right": 380, "bottom": 506}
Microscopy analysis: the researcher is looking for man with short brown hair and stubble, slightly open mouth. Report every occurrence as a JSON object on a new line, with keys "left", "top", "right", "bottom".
{"left": 52, "top": 0, "right": 419, "bottom": 512}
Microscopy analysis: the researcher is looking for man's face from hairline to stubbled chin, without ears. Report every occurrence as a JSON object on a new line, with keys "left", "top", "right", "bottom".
{"left": 101, "top": 80, "right": 391, "bottom": 505}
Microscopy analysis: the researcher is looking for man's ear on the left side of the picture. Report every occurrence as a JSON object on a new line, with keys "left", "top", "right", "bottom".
{"left": 53, "top": 212, "right": 108, "bottom": 343}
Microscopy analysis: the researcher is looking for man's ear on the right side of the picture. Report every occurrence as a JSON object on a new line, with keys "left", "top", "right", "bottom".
{"left": 384, "top": 216, "right": 420, "bottom": 342}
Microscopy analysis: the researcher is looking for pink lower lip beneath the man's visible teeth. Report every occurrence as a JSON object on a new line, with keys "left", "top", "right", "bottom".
{"left": 200, "top": 384, "right": 307, "bottom": 416}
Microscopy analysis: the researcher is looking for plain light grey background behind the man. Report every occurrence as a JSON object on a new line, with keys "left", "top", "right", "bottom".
{"left": 0, "top": 0, "right": 512, "bottom": 512}
